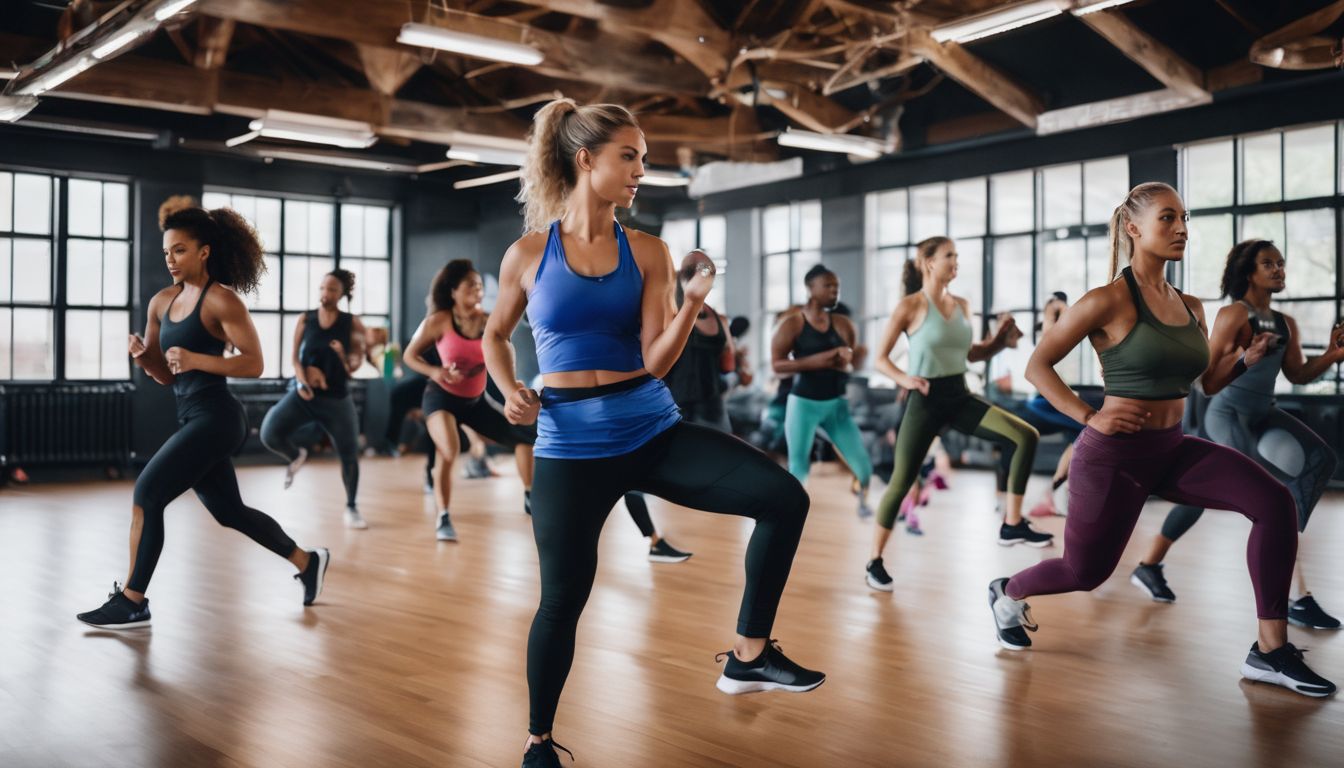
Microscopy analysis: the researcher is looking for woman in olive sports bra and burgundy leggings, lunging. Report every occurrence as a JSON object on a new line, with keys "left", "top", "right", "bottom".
{"left": 989, "top": 182, "right": 1335, "bottom": 697}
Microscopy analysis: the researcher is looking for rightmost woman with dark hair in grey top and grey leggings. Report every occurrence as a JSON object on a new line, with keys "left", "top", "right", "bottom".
{"left": 1130, "top": 239, "right": 1344, "bottom": 629}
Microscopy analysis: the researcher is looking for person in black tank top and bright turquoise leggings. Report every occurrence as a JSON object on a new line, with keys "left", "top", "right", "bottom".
{"left": 770, "top": 264, "right": 872, "bottom": 518}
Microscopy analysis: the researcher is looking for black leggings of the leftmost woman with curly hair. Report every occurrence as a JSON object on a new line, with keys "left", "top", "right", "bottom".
{"left": 126, "top": 395, "right": 294, "bottom": 592}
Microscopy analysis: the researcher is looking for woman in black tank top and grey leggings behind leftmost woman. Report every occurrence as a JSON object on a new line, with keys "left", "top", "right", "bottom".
{"left": 261, "top": 269, "right": 368, "bottom": 530}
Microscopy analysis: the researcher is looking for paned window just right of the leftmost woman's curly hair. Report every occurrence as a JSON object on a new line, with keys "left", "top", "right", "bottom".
{"left": 203, "top": 192, "right": 392, "bottom": 378}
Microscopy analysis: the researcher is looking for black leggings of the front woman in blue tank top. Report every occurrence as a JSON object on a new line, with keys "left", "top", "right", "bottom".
{"left": 527, "top": 422, "right": 808, "bottom": 734}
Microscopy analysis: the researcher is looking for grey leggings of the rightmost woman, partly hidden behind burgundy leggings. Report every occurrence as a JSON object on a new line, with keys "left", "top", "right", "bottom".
{"left": 1163, "top": 393, "right": 1336, "bottom": 541}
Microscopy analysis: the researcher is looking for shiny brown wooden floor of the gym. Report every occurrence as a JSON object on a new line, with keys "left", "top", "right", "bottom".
{"left": 0, "top": 456, "right": 1344, "bottom": 768}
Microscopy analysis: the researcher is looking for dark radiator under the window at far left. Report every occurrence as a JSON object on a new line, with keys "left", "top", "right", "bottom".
{"left": 0, "top": 382, "right": 134, "bottom": 467}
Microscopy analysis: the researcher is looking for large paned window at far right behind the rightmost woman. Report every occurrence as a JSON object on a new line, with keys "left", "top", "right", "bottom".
{"left": 1180, "top": 124, "right": 1341, "bottom": 393}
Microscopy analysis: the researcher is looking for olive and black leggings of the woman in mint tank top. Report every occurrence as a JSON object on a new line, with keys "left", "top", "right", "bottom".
{"left": 878, "top": 374, "right": 1040, "bottom": 529}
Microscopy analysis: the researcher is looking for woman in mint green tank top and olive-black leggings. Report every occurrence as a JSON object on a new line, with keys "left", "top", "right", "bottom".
{"left": 867, "top": 237, "right": 1052, "bottom": 592}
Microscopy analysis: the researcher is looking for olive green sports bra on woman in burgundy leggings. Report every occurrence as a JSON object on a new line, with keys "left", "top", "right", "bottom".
{"left": 1097, "top": 266, "right": 1208, "bottom": 399}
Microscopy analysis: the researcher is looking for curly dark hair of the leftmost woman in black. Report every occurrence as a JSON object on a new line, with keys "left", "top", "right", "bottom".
{"left": 159, "top": 198, "right": 266, "bottom": 293}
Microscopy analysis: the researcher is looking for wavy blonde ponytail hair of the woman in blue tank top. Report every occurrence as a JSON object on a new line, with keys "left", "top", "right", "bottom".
{"left": 517, "top": 98, "right": 638, "bottom": 233}
